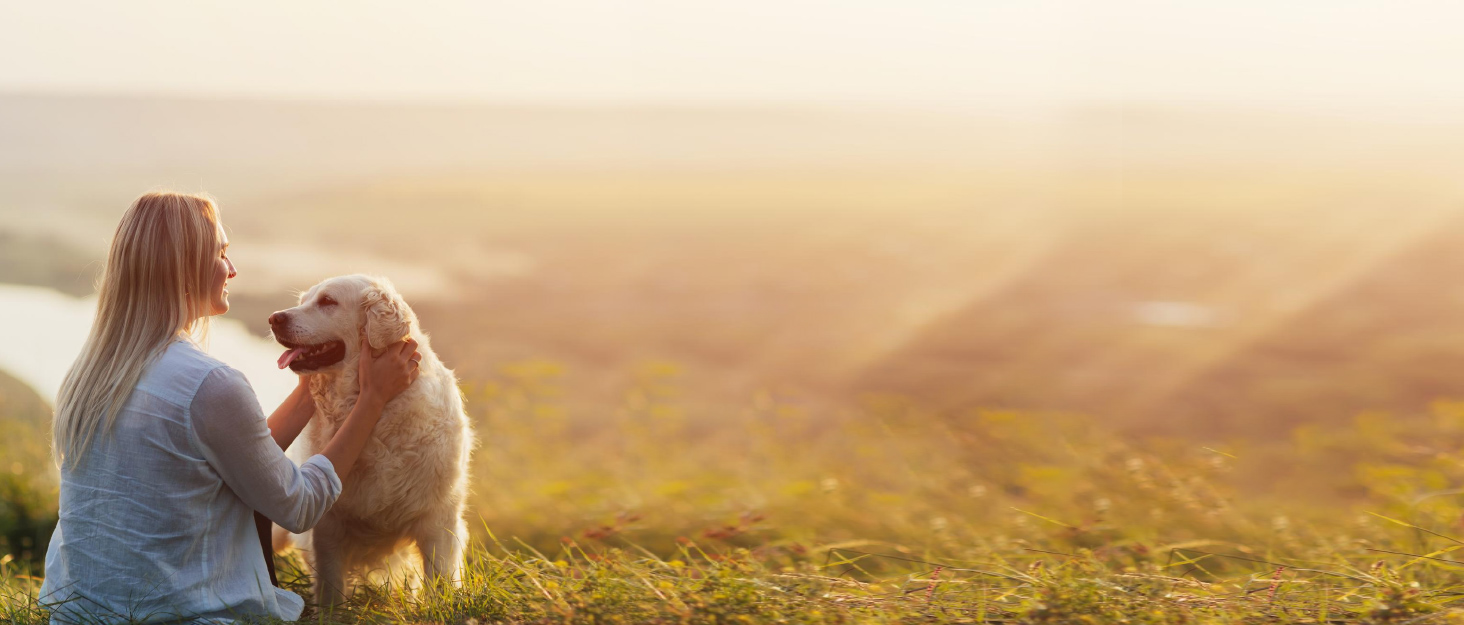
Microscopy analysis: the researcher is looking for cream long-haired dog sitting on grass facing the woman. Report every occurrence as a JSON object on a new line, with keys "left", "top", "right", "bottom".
{"left": 269, "top": 275, "right": 473, "bottom": 606}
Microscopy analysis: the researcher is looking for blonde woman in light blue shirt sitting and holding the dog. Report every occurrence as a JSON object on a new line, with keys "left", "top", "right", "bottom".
{"left": 40, "top": 193, "right": 419, "bottom": 622}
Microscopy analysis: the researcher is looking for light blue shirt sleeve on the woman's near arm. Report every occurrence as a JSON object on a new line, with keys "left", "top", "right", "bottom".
{"left": 190, "top": 367, "right": 341, "bottom": 533}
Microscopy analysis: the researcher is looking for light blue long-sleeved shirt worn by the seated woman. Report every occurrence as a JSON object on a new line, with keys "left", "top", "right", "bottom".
{"left": 40, "top": 340, "right": 341, "bottom": 622}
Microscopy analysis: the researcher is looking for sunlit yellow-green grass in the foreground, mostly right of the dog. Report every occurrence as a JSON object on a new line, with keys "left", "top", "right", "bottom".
{"left": 11, "top": 362, "right": 1464, "bottom": 625}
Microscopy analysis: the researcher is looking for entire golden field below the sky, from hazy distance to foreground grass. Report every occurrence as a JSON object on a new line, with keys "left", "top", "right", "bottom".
{"left": 14, "top": 94, "right": 1464, "bottom": 625}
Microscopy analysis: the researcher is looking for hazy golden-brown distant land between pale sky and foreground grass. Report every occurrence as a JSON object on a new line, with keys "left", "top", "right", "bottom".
{"left": 0, "top": 94, "right": 1464, "bottom": 436}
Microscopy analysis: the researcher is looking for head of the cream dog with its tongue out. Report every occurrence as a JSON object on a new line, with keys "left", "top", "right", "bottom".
{"left": 269, "top": 274, "right": 417, "bottom": 373}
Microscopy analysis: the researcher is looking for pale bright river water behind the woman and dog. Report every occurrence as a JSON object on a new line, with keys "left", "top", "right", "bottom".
{"left": 0, "top": 284, "right": 296, "bottom": 414}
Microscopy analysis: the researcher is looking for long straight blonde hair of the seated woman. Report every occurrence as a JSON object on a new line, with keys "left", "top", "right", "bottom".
{"left": 51, "top": 192, "right": 223, "bottom": 465}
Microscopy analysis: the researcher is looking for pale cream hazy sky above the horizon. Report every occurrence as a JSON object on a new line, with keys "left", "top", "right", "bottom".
{"left": 0, "top": 0, "right": 1464, "bottom": 113}
